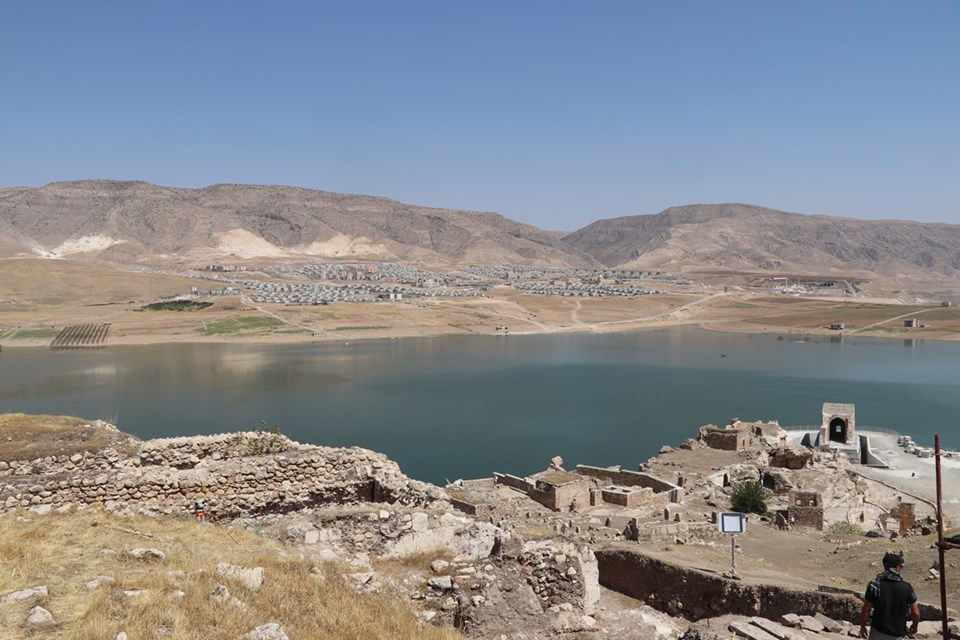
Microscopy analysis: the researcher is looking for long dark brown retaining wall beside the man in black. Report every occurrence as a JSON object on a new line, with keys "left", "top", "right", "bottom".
{"left": 596, "top": 548, "right": 860, "bottom": 622}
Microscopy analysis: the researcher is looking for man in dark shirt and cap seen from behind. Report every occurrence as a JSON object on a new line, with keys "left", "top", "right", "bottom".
{"left": 860, "top": 553, "right": 920, "bottom": 640}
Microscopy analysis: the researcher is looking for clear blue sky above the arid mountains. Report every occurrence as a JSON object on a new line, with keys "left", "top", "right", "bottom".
{"left": 0, "top": 0, "right": 960, "bottom": 230}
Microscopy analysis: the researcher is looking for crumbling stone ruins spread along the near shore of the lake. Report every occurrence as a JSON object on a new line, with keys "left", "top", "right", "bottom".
{"left": 0, "top": 405, "right": 956, "bottom": 640}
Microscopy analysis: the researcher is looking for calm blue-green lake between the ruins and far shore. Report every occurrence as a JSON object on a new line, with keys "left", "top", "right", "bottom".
{"left": 0, "top": 329, "right": 960, "bottom": 483}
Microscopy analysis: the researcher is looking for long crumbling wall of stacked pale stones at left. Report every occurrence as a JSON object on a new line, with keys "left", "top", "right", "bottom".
{"left": 0, "top": 432, "right": 441, "bottom": 518}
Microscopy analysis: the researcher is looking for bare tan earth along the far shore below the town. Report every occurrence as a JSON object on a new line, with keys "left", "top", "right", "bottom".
{"left": 0, "top": 259, "right": 960, "bottom": 347}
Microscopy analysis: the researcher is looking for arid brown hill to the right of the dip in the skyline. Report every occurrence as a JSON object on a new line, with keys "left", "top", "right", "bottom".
{"left": 563, "top": 204, "right": 960, "bottom": 276}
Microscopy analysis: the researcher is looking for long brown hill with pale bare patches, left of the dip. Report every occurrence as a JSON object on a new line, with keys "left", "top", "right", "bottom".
{"left": 0, "top": 180, "right": 596, "bottom": 266}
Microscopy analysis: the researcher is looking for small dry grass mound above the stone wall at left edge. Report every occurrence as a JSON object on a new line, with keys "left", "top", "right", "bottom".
{"left": 0, "top": 413, "right": 132, "bottom": 460}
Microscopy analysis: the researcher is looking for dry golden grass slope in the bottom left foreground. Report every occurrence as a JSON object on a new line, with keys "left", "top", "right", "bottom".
{"left": 0, "top": 509, "right": 460, "bottom": 640}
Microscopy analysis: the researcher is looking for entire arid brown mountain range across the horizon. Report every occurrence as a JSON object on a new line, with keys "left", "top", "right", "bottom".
{"left": 0, "top": 180, "right": 960, "bottom": 278}
